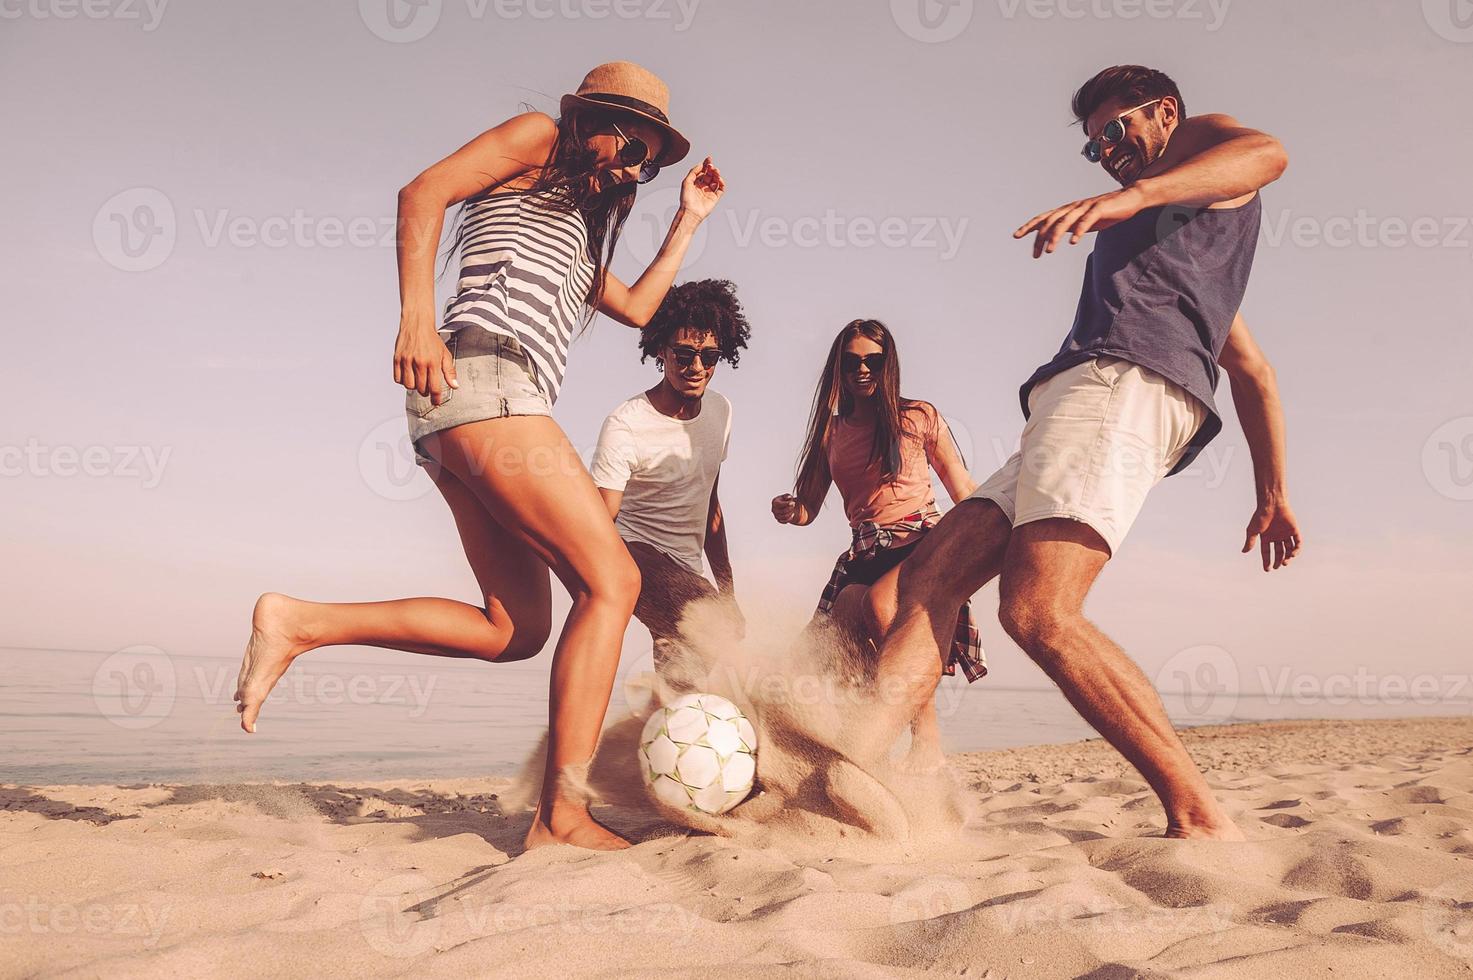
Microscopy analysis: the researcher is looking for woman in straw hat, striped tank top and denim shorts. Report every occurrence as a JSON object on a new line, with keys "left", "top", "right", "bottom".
{"left": 236, "top": 62, "right": 725, "bottom": 849}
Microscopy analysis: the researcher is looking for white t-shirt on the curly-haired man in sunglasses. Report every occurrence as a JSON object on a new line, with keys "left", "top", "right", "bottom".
{"left": 589, "top": 389, "right": 732, "bottom": 575}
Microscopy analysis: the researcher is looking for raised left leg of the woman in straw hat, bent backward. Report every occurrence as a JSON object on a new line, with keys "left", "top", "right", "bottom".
{"left": 236, "top": 467, "right": 552, "bottom": 732}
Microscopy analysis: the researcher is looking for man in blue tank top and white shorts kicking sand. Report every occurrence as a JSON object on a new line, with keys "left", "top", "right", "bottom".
{"left": 876, "top": 65, "right": 1301, "bottom": 840}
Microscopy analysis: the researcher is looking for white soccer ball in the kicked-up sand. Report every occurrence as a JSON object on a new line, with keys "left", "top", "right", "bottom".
{"left": 639, "top": 694, "right": 757, "bottom": 815}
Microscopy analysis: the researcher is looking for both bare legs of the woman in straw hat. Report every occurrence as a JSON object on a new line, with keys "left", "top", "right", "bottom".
{"left": 237, "top": 416, "right": 639, "bottom": 849}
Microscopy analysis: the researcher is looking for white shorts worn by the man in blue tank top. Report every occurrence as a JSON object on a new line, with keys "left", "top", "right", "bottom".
{"left": 972, "top": 357, "right": 1206, "bottom": 554}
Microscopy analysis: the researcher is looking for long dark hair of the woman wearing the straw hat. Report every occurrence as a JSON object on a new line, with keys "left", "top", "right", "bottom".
{"left": 440, "top": 108, "right": 636, "bottom": 329}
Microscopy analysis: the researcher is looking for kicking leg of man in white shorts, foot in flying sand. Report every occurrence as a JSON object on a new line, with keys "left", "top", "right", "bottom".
{"left": 850, "top": 498, "right": 1012, "bottom": 762}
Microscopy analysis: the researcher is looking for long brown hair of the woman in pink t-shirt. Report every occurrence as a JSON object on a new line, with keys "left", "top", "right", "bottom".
{"left": 794, "top": 320, "right": 913, "bottom": 500}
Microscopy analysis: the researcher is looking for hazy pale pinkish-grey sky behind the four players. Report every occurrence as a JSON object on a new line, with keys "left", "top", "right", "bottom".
{"left": 0, "top": 0, "right": 1473, "bottom": 710}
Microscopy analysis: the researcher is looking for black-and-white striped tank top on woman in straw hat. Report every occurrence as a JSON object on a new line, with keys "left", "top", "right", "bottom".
{"left": 443, "top": 190, "right": 594, "bottom": 401}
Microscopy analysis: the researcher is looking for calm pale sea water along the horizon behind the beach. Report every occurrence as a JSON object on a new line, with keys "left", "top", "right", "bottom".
{"left": 0, "top": 647, "right": 1473, "bottom": 784}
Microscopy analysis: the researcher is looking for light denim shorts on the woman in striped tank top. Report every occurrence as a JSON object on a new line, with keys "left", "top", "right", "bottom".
{"left": 404, "top": 327, "right": 552, "bottom": 466}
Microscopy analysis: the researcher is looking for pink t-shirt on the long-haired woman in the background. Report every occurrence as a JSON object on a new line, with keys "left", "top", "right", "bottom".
{"left": 828, "top": 402, "right": 944, "bottom": 528}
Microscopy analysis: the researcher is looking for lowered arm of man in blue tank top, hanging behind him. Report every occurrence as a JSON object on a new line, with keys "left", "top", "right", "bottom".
{"left": 1218, "top": 314, "right": 1304, "bottom": 572}
